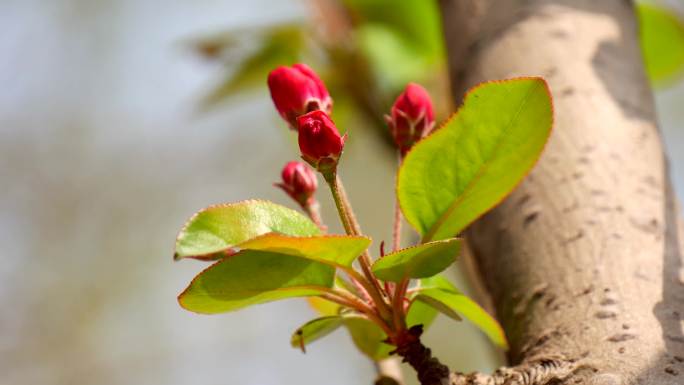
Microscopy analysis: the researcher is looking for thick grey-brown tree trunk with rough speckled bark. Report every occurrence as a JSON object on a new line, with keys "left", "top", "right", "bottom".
{"left": 441, "top": 0, "right": 684, "bottom": 385}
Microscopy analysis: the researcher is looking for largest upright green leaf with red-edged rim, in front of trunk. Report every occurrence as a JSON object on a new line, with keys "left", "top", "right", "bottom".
{"left": 397, "top": 78, "right": 553, "bottom": 242}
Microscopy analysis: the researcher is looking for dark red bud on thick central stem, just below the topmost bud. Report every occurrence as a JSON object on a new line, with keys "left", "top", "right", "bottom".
{"left": 297, "top": 111, "right": 347, "bottom": 173}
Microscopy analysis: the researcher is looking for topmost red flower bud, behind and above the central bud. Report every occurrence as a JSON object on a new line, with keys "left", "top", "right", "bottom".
{"left": 268, "top": 64, "right": 332, "bottom": 130}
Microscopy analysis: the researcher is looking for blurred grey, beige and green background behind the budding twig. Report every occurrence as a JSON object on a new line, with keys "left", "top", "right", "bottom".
{"left": 0, "top": 0, "right": 684, "bottom": 385}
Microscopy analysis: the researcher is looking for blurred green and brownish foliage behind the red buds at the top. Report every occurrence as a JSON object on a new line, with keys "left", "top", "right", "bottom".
{"left": 193, "top": 0, "right": 448, "bottom": 138}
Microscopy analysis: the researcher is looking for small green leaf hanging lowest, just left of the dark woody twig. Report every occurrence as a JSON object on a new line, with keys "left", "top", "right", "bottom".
{"left": 344, "top": 315, "right": 394, "bottom": 361}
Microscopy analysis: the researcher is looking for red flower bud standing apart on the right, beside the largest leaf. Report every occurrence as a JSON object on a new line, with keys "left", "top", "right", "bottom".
{"left": 385, "top": 83, "right": 435, "bottom": 155}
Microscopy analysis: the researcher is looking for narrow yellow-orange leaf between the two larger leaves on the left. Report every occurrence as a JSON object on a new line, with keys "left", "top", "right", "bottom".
{"left": 238, "top": 233, "right": 371, "bottom": 267}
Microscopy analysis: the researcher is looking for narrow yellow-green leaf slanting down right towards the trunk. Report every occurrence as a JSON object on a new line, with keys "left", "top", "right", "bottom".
{"left": 413, "top": 276, "right": 508, "bottom": 349}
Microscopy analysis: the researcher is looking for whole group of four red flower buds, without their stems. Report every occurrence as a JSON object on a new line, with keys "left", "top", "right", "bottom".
{"left": 268, "top": 64, "right": 435, "bottom": 205}
